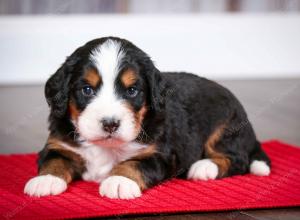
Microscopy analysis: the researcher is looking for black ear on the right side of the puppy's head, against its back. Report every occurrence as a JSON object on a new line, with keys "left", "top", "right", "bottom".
{"left": 146, "top": 64, "right": 166, "bottom": 112}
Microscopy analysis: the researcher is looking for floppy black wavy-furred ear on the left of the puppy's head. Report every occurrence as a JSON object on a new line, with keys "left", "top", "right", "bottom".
{"left": 45, "top": 61, "right": 71, "bottom": 118}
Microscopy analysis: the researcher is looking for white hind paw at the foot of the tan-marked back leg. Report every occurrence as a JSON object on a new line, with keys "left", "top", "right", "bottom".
{"left": 188, "top": 159, "right": 218, "bottom": 180}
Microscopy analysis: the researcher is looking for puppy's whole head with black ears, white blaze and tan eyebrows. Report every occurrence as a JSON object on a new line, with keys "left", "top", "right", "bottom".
{"left": 45, "top": 37, "right": 161, "bottom": 147}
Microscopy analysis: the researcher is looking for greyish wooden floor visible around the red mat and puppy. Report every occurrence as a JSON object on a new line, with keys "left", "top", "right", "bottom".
{"left": 0, "top": 79, "right": 300, "bottom": 220}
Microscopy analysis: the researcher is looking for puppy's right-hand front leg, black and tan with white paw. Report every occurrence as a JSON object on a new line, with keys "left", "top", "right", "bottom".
{"left": 100, "top": 150, "right": 171, "bottom": 199}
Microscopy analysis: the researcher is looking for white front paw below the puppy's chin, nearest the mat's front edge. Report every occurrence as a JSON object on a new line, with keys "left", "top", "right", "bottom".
{"left": 100, "top": 176, "right": 142, "bottom": 199}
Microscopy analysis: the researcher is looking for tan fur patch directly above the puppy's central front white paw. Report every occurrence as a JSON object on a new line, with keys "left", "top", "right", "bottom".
{"left": 110, "top": 161, "right": 147, "bottom": 190}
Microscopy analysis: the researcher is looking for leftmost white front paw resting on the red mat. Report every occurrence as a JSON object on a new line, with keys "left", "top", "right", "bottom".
{"left": 24, "top": 174, "right": 67, "bottom": 197}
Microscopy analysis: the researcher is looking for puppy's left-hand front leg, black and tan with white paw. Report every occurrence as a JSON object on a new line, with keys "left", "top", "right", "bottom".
{"left": 24, "top": 138, "right": 84, "bottom": 197}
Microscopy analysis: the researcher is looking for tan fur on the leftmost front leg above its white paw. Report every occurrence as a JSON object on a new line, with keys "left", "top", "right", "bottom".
{"left": 39, "top": 137, "right": 85, "bottom": 183}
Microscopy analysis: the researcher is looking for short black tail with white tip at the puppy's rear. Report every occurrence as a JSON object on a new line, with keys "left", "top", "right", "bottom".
{"left": 250, "top": 141, "right": 271, "bottom": 176}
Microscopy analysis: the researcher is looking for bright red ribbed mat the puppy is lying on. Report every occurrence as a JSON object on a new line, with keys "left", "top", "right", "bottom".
{"left": 0, "top": 141, "right": 300, "bottom": 219}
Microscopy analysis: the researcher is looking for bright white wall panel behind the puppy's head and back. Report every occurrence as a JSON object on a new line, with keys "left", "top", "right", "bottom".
{"left": 0, "top": 14, "right": 300, "bottom": 84}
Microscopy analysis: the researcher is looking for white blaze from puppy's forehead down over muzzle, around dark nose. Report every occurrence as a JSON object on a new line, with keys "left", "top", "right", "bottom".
{"left": 78, "top": 39, "right": 137, "bottom": 141}
